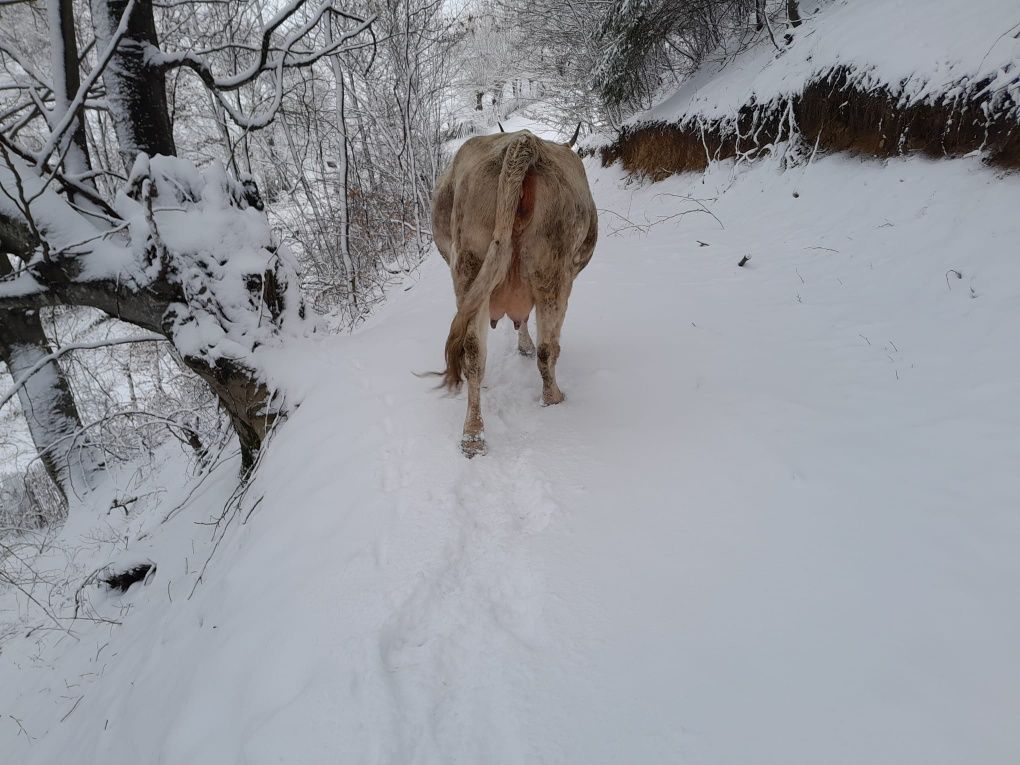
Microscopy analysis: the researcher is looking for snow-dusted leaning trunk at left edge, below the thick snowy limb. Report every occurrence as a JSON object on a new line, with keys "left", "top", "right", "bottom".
{"left": 0, "top": 252, "right": 102, "bottom": 499}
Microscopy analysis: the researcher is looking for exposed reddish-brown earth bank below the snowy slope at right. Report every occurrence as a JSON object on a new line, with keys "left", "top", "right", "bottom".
{"left": 601, "top": 67, "right": 1020, "bottom": 181}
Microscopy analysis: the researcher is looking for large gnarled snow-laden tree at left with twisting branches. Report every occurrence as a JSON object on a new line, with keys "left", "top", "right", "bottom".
{"left": 0, "top": 0, "right": 372, "bottom": 479}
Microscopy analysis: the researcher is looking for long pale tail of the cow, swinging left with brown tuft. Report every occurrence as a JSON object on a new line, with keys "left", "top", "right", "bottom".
{"left": 442, "top": 135, "right": 539, "bottom": 391}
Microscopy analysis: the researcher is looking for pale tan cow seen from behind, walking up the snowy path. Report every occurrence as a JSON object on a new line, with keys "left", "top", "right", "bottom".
{"left": 432, "top": 125, "right": 599, "bottom": 457}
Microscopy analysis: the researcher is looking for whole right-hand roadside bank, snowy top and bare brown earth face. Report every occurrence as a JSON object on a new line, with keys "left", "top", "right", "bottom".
{"left": 590, "top": 0, "right": 1020, "bottom": 180}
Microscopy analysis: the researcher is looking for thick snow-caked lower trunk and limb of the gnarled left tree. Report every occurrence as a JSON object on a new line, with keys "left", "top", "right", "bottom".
{"left": 0, "top": 144, "right": 305, "bottom": 467}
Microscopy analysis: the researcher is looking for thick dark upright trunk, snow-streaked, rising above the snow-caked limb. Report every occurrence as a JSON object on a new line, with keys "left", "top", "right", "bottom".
{"left": 92, "top": 0, "right": 176, "bottom": 170}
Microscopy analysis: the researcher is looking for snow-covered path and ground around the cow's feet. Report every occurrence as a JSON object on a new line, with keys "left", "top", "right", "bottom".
{"left": 0, "top": 146, "right": 1020, "bottom": 765}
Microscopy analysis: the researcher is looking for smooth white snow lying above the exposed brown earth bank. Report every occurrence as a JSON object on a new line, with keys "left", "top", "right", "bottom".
{"left": 632, "top": 0, "right": 1020, "bottom": 121}
